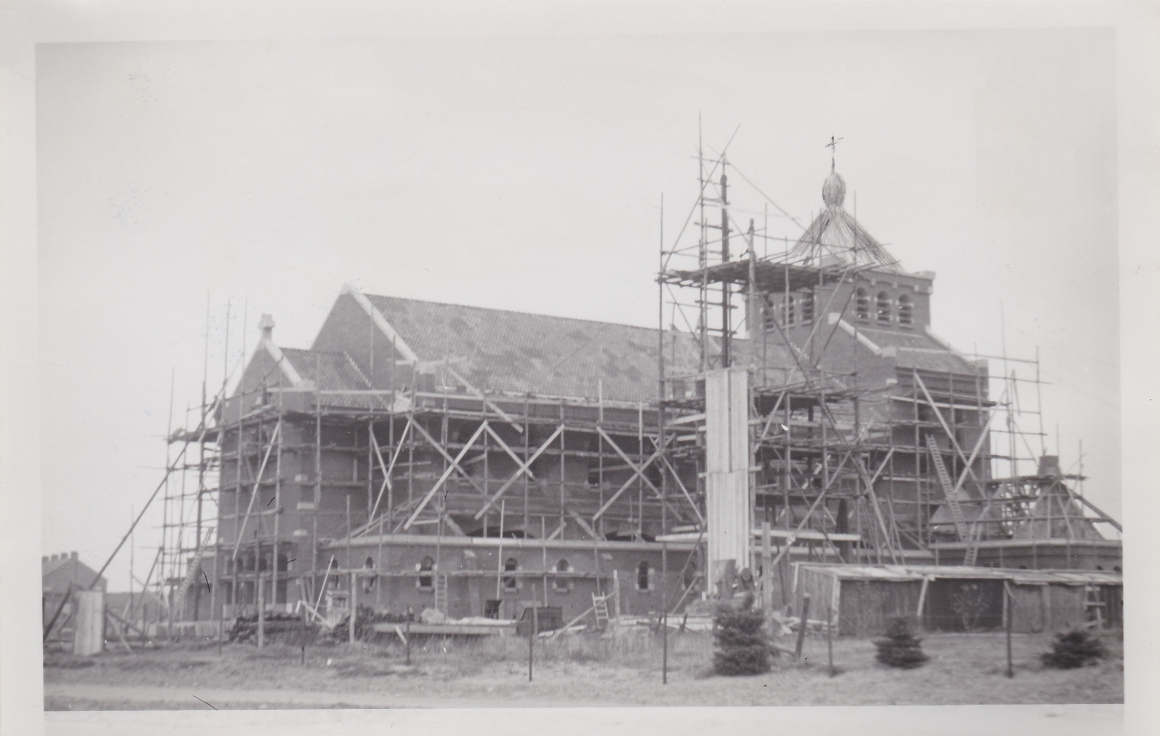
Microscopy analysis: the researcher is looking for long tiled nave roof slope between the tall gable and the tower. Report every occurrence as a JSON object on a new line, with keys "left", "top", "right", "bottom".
{"left": 368, "top": 295, "right": 699, "bottom": 401}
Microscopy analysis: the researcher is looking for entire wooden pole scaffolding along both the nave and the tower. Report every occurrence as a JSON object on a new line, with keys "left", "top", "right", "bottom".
{"left": 102, "top": 138, "right": 1119, "bottom": 629}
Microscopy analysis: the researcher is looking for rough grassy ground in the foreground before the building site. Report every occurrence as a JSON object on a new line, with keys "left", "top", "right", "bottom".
{"left": 44, "top": 627, "right": 1124, "bottom": 710}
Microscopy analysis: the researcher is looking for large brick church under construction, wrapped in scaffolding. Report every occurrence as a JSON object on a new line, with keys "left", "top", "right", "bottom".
{"left": 151, "top": 152, "right": 1122, "bottom": 621}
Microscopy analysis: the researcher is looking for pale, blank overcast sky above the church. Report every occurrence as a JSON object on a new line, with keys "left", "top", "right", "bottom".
{"left": 36, "top": 29, "right": 1121, "bottom": 590}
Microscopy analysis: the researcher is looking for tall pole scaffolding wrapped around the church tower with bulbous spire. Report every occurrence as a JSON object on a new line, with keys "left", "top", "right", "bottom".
{"left": 658, "top": 141, "right": 1119, "bottom": 603}
